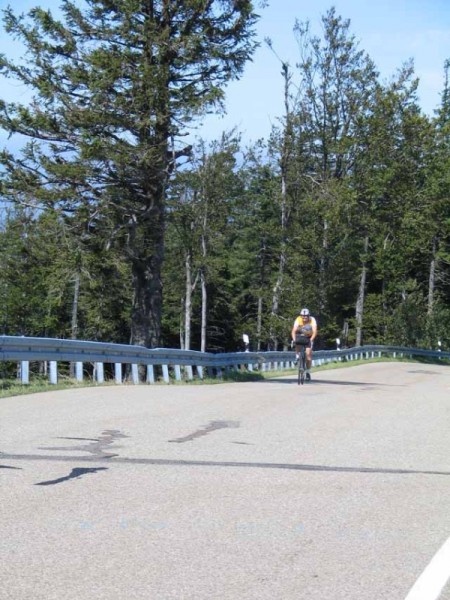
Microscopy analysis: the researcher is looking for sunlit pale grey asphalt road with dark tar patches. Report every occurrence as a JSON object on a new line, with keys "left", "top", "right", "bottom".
{"left": 0, "top": 363, "right": 450, "bottom": 600}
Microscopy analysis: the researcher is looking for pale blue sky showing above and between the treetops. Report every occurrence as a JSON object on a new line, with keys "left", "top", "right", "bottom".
{"left": 0, "top": 0, "right": 450, "bottom": 145}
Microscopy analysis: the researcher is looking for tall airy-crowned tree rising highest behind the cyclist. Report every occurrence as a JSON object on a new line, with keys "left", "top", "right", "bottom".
{"left": 284, "top": 8, "right": 378, "bottom": 346}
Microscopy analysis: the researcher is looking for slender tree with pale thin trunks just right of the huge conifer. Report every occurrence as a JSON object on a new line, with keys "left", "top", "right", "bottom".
{"left": 164, "top": 131, "right": 243, "bottom": 351}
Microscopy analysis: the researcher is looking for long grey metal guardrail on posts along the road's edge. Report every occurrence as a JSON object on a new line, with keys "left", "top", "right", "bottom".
{"left": 0, "top": 336, "right": 450, "bottom": 384}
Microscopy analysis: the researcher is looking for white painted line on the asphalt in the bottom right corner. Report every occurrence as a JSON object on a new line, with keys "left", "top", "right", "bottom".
{"left": 405, "top": 538, "right": 450, "bottom": 600}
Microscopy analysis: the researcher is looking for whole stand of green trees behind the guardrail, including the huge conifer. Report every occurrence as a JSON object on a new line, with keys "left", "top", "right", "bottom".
{"left": 0, "top": 0, "right": 450, "bottom": 351}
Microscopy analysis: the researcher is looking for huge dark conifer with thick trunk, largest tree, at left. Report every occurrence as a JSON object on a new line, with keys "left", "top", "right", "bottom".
{"left": 0, "top": 0, "right": 257, "bottom": 346}
